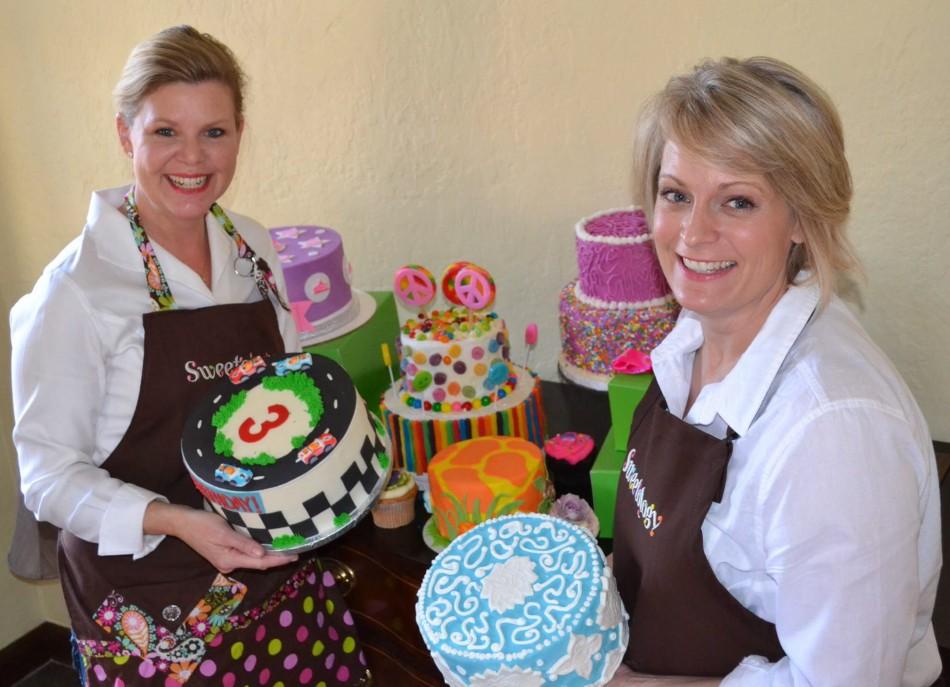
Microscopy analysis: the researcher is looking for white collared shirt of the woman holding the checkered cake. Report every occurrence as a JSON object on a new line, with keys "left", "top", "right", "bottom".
{"left": 10, "top": 187, "right": 300, "bottom": 557}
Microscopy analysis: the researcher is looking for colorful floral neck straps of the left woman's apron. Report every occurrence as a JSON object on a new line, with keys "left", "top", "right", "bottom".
{"left": 124, "top": 189, "right": 290, "bottom": 311}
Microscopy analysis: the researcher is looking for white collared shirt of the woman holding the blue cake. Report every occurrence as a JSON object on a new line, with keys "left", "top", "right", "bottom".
{"left": 652, "top": 286, "right": 941, "bottom": 687}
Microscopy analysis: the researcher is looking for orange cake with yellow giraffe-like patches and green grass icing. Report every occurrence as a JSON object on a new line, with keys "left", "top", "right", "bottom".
{"left": 429, "top": 437, "right": 549, "bottom": 540}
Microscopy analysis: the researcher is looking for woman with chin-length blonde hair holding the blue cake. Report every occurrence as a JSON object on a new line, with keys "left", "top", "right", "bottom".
{"left": 609, "top": 57, "right": 941, "bottom": 687}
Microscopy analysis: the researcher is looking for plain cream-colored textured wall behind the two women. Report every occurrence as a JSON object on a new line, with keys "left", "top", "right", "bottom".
{"left": 0, "top": 0, "right": 950, "bottom": 646}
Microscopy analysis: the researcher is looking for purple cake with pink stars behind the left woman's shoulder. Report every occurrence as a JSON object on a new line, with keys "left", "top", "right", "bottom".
{"left": 270, "top": 226, "right": 359, "bottom": 345}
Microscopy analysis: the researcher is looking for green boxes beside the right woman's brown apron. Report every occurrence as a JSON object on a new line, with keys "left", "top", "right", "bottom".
{"left": 590, "top": 372, "right": 653, "bottom": 539}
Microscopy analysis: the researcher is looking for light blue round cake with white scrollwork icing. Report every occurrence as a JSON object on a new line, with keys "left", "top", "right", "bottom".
{"left": 416, "top": 513, "right": 629, "bottom": 687}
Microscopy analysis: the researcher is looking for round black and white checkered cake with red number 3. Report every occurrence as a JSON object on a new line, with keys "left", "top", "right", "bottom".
{"left": 182, "top": 353, "right": 390, "bottom": 551}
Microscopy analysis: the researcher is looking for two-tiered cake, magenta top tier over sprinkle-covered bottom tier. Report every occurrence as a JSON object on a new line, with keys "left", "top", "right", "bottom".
{"left": 558, "top": 208, "right": 679, "bottom": 389}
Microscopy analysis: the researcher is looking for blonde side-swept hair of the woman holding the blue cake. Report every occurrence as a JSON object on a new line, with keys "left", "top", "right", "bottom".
{"left": 634, "top": 57, "right": 859, "bottom": 303}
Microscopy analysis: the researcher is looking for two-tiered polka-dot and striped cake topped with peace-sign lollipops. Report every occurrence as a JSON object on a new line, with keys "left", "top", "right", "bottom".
{"left": 381, "top": 262, "right": 545, "bottom": 475}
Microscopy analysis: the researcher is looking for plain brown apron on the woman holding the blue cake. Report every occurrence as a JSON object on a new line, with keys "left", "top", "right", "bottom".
{"left": 614, "top": 381, "right": 785, "bottom": 677}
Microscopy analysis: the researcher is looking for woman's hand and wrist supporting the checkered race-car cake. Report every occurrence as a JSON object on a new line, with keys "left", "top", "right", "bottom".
{"left": 143, "top": 501, "right": 297, "bottom": 574}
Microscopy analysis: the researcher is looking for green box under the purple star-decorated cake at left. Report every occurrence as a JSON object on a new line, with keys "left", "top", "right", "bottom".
{"left": 304, "top": 291, "right": 399, "bottom": 415}
